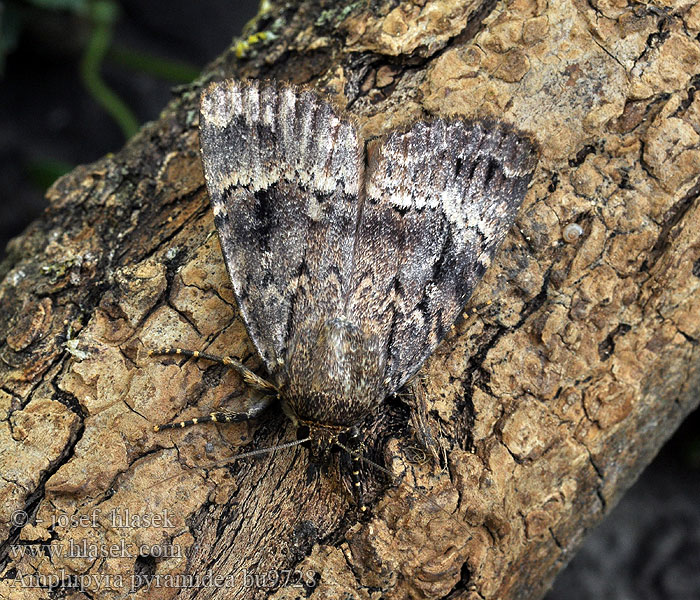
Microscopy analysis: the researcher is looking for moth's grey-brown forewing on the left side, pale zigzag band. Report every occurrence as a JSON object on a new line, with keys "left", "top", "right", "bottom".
{"left": 200, "top": 80, "right": 364, "bottom": 374}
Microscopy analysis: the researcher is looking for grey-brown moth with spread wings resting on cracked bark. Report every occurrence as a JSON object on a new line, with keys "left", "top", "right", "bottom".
{"left": 156, "top": 80, "right": 537, "bottom": 510}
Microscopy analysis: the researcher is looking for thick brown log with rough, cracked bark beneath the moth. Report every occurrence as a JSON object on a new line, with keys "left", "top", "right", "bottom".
{"left": 0, "top": 0, "right": 700, "bottom": 599}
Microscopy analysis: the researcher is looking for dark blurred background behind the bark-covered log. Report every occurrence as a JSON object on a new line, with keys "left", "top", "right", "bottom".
{"left": 0, "top": 0, "right": 700, "bottom": 600}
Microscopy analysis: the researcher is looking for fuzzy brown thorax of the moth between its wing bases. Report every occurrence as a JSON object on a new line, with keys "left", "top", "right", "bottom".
{"left": 280, "top": 317, "right": 385, "bottom": 428}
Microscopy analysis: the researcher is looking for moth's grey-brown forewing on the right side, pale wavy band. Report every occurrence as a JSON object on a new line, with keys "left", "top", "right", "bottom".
{"left": 346, "top": 119, "right": 537, "bottom": 392}
